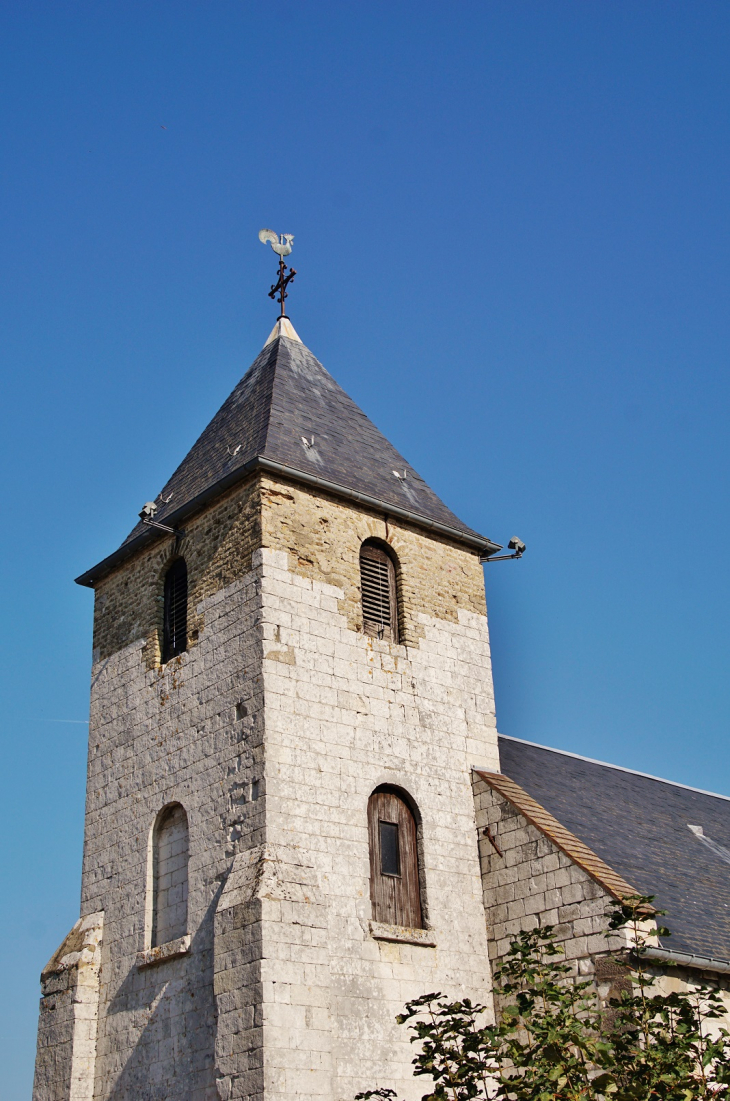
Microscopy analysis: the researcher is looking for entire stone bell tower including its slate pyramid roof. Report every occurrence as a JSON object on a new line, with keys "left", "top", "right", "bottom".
{"left": 33, "top": 318, "right": 499, "bottom": 1101}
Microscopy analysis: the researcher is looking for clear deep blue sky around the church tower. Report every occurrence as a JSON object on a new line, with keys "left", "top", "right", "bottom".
{"left": 0, "top": 0, "right": 730, "bottom": 1101}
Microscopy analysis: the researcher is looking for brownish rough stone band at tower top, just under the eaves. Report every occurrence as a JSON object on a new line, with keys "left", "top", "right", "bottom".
{"left": 94, "top": 475, "right": 484, "bottom": 668}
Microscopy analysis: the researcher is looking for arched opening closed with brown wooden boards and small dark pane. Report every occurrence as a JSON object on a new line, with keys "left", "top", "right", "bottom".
{"left": 368, "top": 791, "right": 423, "bottom": 929}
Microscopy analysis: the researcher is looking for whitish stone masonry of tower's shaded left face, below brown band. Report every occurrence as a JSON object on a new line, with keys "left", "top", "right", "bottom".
{"left": 81, "top": 570, "right": 264, "bottom": 1101}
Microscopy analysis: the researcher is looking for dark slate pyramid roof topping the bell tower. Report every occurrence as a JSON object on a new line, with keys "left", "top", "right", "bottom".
{"left": 77, "top": 318, "right": 499, "bottom": 585}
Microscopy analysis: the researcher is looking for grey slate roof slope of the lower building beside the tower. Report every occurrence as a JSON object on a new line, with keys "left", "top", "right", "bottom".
{"left": 499, "top": 737, "right": 730, "bottom": 960}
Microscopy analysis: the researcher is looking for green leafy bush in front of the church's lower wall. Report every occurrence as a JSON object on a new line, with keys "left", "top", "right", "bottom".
{"left": 357, "top": 895, "right": 730, "bottom": 1101}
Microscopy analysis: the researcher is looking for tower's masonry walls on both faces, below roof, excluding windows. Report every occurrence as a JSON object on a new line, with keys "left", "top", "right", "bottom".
{"left": 41, "top": 479, "right": 498, "bottom": 1101}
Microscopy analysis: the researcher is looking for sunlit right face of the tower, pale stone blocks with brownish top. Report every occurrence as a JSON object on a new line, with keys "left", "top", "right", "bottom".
{"left": 254, "top": 521, "right": 498, "bottom": 1101}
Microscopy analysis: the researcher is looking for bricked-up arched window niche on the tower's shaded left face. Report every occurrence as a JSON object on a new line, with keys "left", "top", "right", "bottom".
{"left": 150, "top": 803, "right": 188, "bottom": 948}
